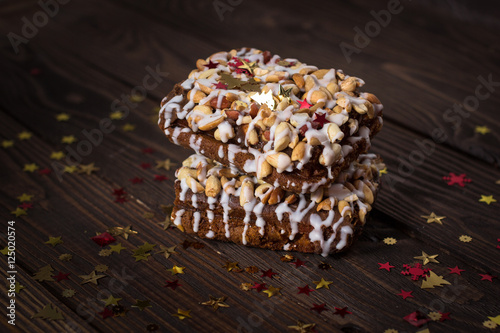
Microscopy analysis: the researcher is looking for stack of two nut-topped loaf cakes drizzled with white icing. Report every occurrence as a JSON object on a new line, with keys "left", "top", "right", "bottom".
{"left": 159, "top": 48, "right": 383, "bottom": 255}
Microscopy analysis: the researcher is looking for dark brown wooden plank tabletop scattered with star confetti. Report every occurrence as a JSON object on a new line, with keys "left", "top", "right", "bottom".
{"left": 0, "top": 0, "right": 500, "bottom": 333}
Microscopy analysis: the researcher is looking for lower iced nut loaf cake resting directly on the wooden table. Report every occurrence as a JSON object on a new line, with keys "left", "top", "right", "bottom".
{"left": 172, "top": 154, "right": 383, "bottom": 256}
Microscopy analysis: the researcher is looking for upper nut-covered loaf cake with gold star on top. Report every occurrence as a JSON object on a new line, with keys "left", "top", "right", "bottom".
{"left": 159, "top": 48, "right": 383, "bottom": 193}
